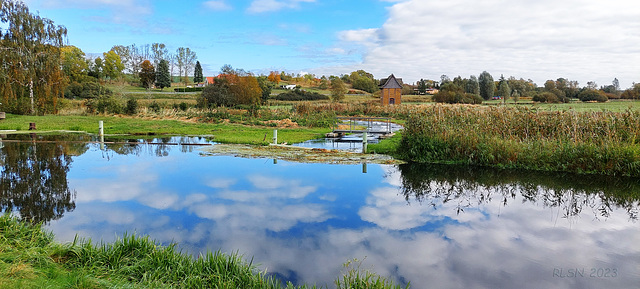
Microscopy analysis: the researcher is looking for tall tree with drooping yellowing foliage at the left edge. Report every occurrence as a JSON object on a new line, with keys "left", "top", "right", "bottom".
{"left": 0, "top": 0, "right": 67, "bottom": 114}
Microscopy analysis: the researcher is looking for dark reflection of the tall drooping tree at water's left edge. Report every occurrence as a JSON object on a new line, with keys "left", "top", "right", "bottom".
{"left": 0, "top": 135, "right": 88, "bottom": 222}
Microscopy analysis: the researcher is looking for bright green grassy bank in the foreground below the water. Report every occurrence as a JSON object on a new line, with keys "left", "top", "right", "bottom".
{"left": 0, "top": 214, "right": 408, "bottom": 288}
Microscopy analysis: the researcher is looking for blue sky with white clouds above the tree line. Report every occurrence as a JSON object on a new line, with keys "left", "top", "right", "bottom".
{"left": 17, "top": 0, "right": 640, "bottom": 89}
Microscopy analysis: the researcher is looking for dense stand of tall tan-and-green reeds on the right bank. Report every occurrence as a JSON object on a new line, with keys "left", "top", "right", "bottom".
{"left": 397, "top": 105, "right": 640, "bottom": 176}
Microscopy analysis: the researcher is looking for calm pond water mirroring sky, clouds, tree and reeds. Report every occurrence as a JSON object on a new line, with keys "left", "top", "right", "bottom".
{"left": 0, "top": 136, "right": 640, "bottom": 288}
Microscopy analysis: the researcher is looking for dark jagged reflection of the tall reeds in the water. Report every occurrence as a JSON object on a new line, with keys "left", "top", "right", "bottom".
{"left": 398, "top": 164, "right": 640, "bottom": 220}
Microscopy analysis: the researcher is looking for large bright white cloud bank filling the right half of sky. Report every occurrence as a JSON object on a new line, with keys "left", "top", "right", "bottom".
{"left": 338, "top": 0, "right": 640, "bottom": 87}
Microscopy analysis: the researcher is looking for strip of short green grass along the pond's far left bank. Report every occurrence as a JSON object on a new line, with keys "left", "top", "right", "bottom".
{"left": 0, "top": 114, "right": 330, "bottom": 144}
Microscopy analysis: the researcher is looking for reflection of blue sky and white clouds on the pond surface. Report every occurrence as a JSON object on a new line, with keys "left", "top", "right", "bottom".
{"left": 50, "top": 146, "right": 640, "bottom": 288}
